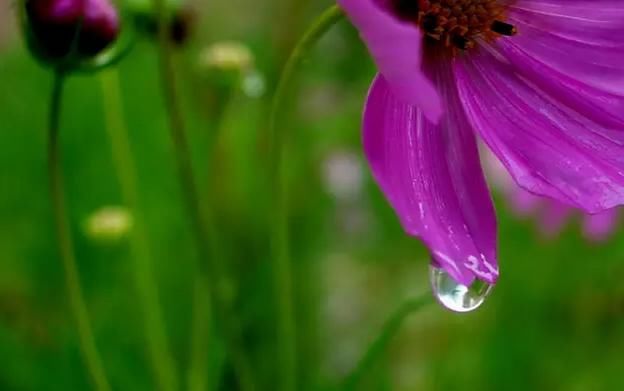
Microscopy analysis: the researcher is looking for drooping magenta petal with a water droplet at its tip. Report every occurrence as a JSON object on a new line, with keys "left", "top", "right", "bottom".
{"left": 364, "top": 75, "right": 498, "bottom": 284}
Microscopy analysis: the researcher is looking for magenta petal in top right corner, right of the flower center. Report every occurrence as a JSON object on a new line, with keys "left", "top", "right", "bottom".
{"left": 497, "top": 0, "right": 624, "bottom": 128}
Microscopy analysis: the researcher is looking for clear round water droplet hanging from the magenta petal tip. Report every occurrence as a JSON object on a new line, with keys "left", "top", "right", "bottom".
{"left": 429, "top": 265, "right": 494, "bottom": 312}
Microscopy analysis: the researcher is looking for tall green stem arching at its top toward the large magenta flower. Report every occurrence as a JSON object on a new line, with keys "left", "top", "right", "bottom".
{"left": 269, "top": 5, "right": 344, "bottom": 391}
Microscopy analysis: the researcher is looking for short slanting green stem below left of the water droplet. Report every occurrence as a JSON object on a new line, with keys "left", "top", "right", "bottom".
{"left": 343, "top": 295, "right": 433, "bottom": 391}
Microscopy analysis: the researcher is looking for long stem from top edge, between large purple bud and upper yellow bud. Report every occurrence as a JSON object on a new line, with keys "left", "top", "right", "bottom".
{"left": 153, "top": 0, "right": 255, "bottom": 390}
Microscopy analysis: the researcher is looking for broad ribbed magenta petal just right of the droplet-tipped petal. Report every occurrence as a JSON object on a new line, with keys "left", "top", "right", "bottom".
{"left": 455, "top": 46, "right": 624, "bottom": 213}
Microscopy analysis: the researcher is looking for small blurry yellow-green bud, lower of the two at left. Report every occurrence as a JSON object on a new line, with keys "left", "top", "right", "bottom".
{"left": 85, "top": 206, "right": 134, "bottom": 243}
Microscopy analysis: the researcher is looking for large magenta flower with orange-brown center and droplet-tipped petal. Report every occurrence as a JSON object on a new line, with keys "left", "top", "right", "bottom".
{"left": 338, "top": 0, "right": 624, "bottom": 285}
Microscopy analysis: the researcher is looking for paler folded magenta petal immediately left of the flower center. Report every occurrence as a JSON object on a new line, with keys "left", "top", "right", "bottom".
{"left": 338, "top": 0, "right": 442, "bottom": 123}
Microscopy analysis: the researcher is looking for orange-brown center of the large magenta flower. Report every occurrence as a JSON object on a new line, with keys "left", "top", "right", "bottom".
{"left": 392, "top": 0, "right": 516, "bottom": 55}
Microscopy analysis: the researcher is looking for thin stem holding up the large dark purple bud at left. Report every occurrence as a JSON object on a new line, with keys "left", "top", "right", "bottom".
{"left": 48, "top": 71, "right": 110, "bottom": 391}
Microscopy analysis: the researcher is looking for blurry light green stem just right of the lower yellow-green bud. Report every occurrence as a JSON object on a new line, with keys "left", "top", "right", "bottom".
{"left": 101, "top": 70, "right": 178, "bottom": 390}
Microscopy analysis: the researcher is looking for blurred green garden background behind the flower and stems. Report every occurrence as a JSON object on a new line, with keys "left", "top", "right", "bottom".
{"left": 0, "top": 0, "right": 624, "bottom": 391}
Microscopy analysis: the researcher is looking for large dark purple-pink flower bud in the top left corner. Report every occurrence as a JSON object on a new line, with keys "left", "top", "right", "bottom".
{"left": 26, "top": 0, "right": 119, "bottom": 60}
